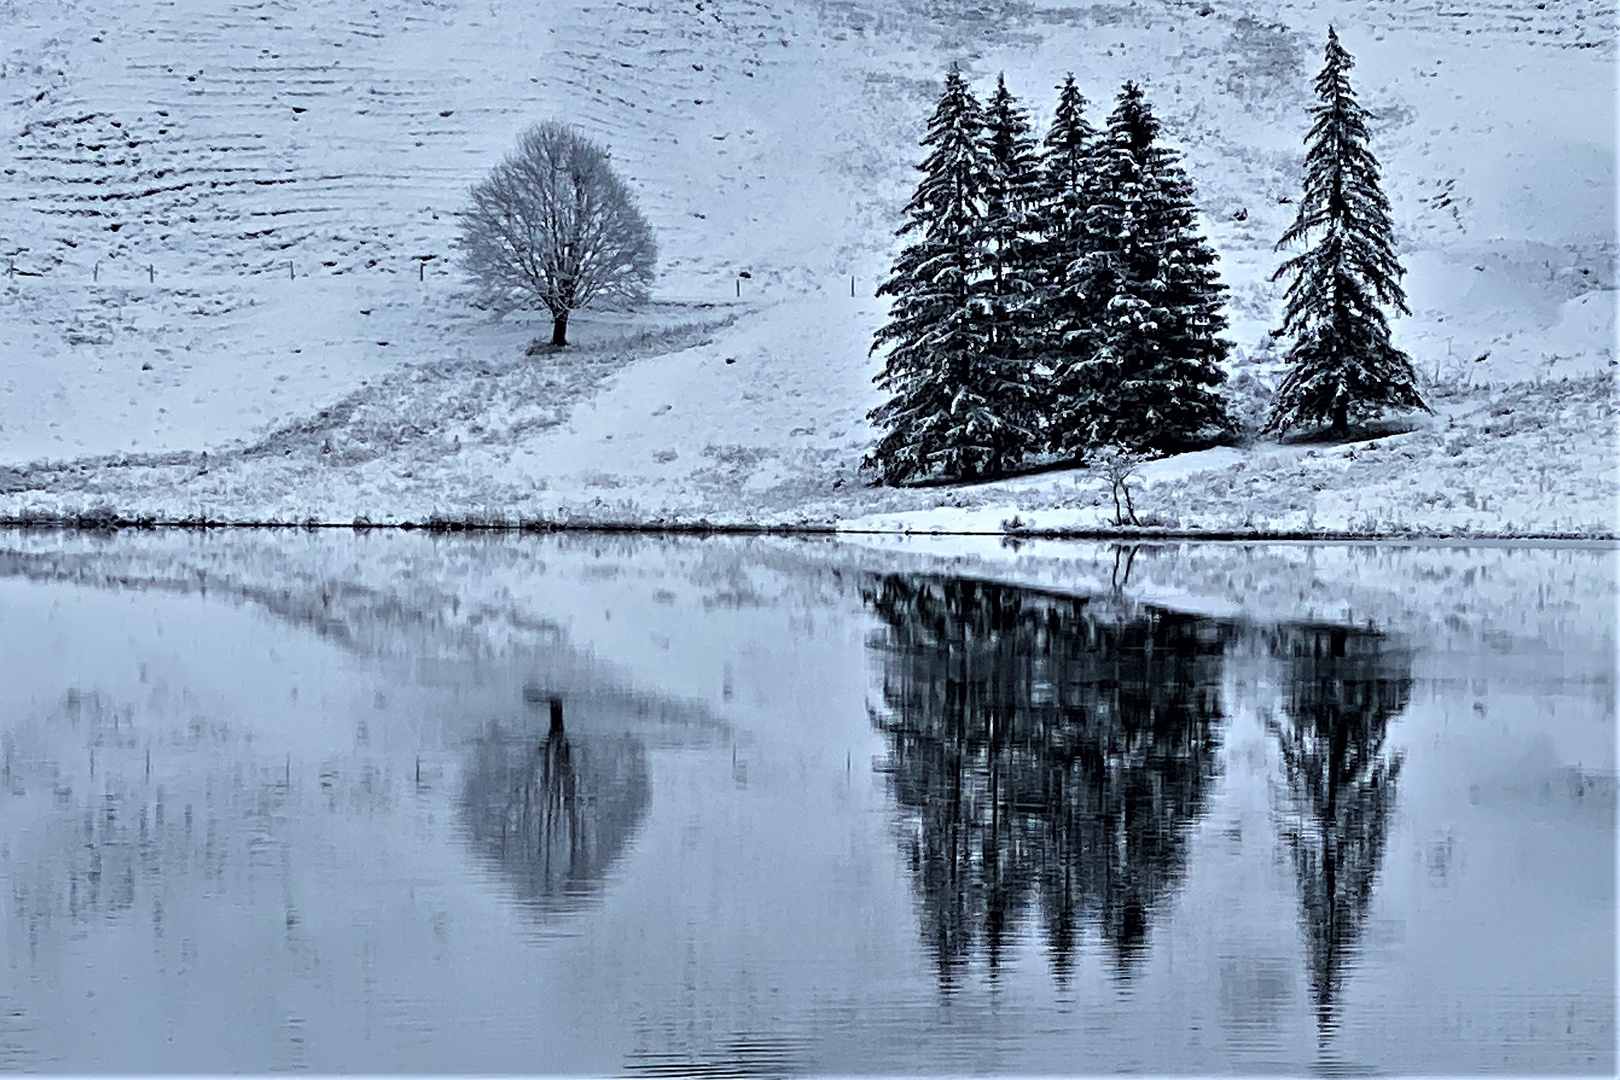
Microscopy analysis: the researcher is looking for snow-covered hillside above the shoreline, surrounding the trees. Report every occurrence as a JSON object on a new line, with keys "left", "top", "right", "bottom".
{"left": 0, "top": 0, "right": 1620, "bottom": 536}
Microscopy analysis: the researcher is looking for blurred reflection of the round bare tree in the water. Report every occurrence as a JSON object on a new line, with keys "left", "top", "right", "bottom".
{"left": 462, "top": 701, "right": 650, "bottom": 915}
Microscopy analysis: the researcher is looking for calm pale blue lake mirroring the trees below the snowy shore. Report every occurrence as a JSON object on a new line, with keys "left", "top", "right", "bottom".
{"left": 0, "top": 531, "right": 1617, "bottom": 1075}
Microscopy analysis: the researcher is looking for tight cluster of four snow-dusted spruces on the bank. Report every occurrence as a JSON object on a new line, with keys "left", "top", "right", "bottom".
{"left": 868, "top": 68, "right": 1230, "bottom": 484}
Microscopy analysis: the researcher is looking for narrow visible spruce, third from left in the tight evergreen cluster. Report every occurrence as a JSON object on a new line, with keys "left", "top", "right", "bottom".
{"left": 1035, "top": 74, "right": 1097, "bottom": 452}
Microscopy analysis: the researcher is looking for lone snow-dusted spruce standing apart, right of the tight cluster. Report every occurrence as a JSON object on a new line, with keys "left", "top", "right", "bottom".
{"left": 1267, "top": 28, "right": 1434, "bottom": 436}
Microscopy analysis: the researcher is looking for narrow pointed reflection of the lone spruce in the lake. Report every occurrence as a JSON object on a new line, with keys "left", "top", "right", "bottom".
{"left": 1272, "top": 627, "right": 1411, "bottom": 1035}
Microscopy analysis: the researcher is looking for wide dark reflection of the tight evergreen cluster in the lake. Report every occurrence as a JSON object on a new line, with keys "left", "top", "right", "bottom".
{"left": 865, "top": 576, "right": 1225, "bottom": 986}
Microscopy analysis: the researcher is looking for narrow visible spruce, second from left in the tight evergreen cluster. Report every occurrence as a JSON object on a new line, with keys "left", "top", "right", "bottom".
{"left": 983, "top": 74, "right": 1042, "bottom": 440}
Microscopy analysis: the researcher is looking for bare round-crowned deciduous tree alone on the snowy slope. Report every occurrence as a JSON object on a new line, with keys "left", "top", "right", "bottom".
{"left": 458, "top": 121, "right": 658, "bottom": 345}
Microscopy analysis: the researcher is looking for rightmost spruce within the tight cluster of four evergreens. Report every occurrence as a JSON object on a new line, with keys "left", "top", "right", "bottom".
{"left": 1051, "top": 83, "right": 1231, "bottom": 455}
